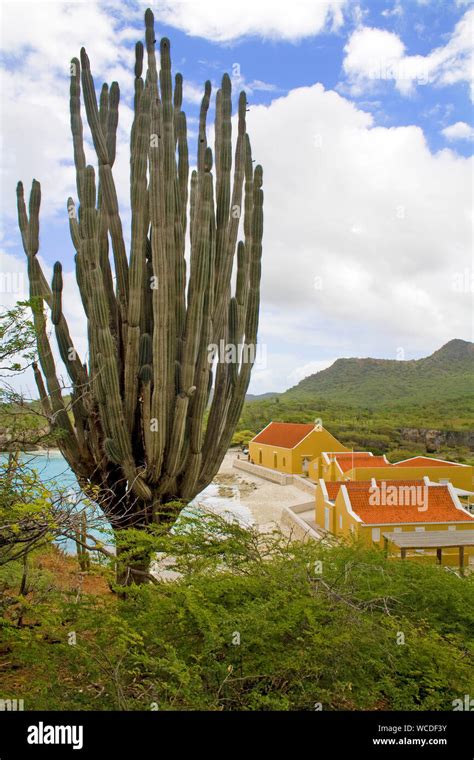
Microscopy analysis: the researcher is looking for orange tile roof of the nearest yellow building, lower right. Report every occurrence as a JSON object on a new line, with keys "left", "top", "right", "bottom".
{"left": 347, "top": 481, "right": 474, "bottom": 525}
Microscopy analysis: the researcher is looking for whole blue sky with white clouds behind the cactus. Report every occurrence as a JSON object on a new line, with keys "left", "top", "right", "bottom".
{"left": 1, "top": 0, "right": 473, "bottom": 395}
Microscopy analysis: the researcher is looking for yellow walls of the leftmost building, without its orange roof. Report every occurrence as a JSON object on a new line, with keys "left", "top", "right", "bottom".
{"left": 249, "top": 428, "right": 349, "bottom": 475}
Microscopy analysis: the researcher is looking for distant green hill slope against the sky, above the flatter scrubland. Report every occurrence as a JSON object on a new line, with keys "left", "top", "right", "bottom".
{"left": 280, "top": 340, "right": 474, "bottom": 408}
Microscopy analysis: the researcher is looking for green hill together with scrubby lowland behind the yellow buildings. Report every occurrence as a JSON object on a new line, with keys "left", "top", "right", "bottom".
{"left": 238, "top": 340, "right": 474, "bottom": 463}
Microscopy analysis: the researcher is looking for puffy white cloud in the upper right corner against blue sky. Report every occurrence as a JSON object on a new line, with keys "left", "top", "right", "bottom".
{"left": 343, "top": 10, "right": 474, "bottom": 95}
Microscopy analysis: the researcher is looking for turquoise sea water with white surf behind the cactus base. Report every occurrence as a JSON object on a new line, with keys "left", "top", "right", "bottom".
{"left": 0, "top": 451, "right": 254, "bottom": 554}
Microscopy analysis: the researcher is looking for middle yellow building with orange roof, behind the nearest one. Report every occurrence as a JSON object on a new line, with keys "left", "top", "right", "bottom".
{"left": 309, "top": 451, "right": 474, "bottom": 495}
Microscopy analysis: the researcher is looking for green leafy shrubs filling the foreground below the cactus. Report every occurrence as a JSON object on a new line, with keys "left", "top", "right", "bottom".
{"left": 0, "top": 515, "right": 474, "bottom": 710}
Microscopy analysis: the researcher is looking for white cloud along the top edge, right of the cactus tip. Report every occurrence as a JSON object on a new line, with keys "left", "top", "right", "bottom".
{"left": 153, "top": 0, "right": 347, "bottom": 42}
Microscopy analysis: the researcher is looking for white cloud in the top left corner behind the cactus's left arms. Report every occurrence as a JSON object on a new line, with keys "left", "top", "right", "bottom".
{"left": 1, "top": 0, "right": 143, "bottom": 222}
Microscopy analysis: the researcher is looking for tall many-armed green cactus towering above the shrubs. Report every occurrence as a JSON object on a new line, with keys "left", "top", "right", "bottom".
{"left": 17, "top": 5, "right": 263, "bottom": 580}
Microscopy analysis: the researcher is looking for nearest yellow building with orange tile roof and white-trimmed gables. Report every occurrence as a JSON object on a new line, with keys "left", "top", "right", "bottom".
{"left": 315, "top": 477, "right": 474, "bottom": 565}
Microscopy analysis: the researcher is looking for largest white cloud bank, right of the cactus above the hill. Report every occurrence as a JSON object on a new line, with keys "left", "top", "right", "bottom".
{"left": 244, "top": 84, "right": 472, "bottom": 374}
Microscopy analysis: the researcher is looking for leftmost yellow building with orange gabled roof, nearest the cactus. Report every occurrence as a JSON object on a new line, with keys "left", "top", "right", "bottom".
{"left": 249, "top": 422, "right": 348, "bottom": 475}
